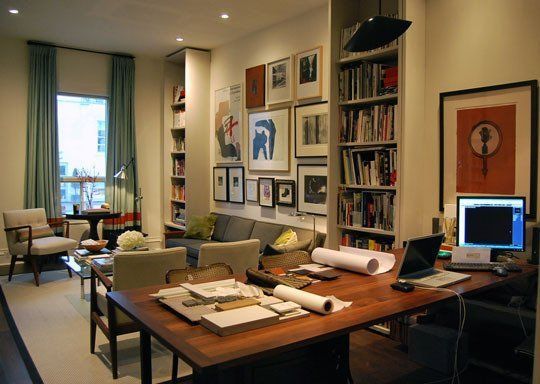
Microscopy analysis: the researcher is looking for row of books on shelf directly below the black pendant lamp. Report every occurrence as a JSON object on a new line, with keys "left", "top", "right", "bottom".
{"left": 339, "top": 62, "right": 397, "bottom": 101}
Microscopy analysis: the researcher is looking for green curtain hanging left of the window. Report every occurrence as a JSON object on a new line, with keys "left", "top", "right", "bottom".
{"left": 24, "top": 45, "right": 61, "bottom": 219}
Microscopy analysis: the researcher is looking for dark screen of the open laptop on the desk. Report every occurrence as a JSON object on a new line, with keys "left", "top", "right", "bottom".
{"left": 398, "top": 233, "right": 444, "bottom": 277}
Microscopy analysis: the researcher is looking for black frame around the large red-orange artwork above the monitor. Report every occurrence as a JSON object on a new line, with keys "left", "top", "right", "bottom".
{"left": 439, "top": 80, "right": 538, "bottom": 220}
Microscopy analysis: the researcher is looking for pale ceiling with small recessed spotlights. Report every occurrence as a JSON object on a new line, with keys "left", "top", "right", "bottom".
{"left": 0, "top": 0, "right": 327, "bottom": 57}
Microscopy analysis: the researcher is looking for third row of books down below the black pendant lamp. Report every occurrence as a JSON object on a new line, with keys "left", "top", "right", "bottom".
{"left": 341, "top": 147, "right": 397, "bottom": 186}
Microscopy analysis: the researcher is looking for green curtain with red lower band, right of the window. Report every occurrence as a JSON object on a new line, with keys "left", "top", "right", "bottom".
{"left": 104, "top": 56, "right": 141, "bottom": 235}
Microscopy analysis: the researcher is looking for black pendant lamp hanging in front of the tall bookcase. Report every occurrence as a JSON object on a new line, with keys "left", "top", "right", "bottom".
{"left": 345, "top": 0, "right": 412, "bottom": 52}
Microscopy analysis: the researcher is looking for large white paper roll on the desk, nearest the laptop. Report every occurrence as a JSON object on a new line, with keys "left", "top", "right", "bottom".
{"left": 311, "top": 246, "right": 396, "bottom": 275}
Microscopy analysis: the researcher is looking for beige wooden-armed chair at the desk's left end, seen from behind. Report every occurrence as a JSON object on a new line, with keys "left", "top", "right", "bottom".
{"left": 90, "top": 247, "right": 186, "bottom": 379}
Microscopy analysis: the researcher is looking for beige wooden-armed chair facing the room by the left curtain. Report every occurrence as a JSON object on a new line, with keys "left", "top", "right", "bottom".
{"left": 4, "top": 208, "right": 77, "bottom": 286}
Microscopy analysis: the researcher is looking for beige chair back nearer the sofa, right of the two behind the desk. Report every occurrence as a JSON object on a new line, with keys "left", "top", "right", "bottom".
{"left": 198, "top": 239, "right": 260, "bottom": 273}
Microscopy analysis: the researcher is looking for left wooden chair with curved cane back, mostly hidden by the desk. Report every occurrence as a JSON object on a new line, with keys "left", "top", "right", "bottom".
{"left": 165, "top": 260, "right": 233, "bottom": 384}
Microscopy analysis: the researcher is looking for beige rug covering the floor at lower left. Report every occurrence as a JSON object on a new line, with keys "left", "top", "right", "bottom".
{"left": 0, "top": 270, "right": 191, "bottom": 384}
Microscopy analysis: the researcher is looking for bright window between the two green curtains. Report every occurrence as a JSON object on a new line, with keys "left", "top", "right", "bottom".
{"left": 57, "top": 94, "right": 108, "bottom": 213}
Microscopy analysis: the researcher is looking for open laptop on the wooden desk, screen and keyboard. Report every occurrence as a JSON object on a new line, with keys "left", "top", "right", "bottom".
{"left": 398, "top": 233, "right": 471, "bottom": 288}
